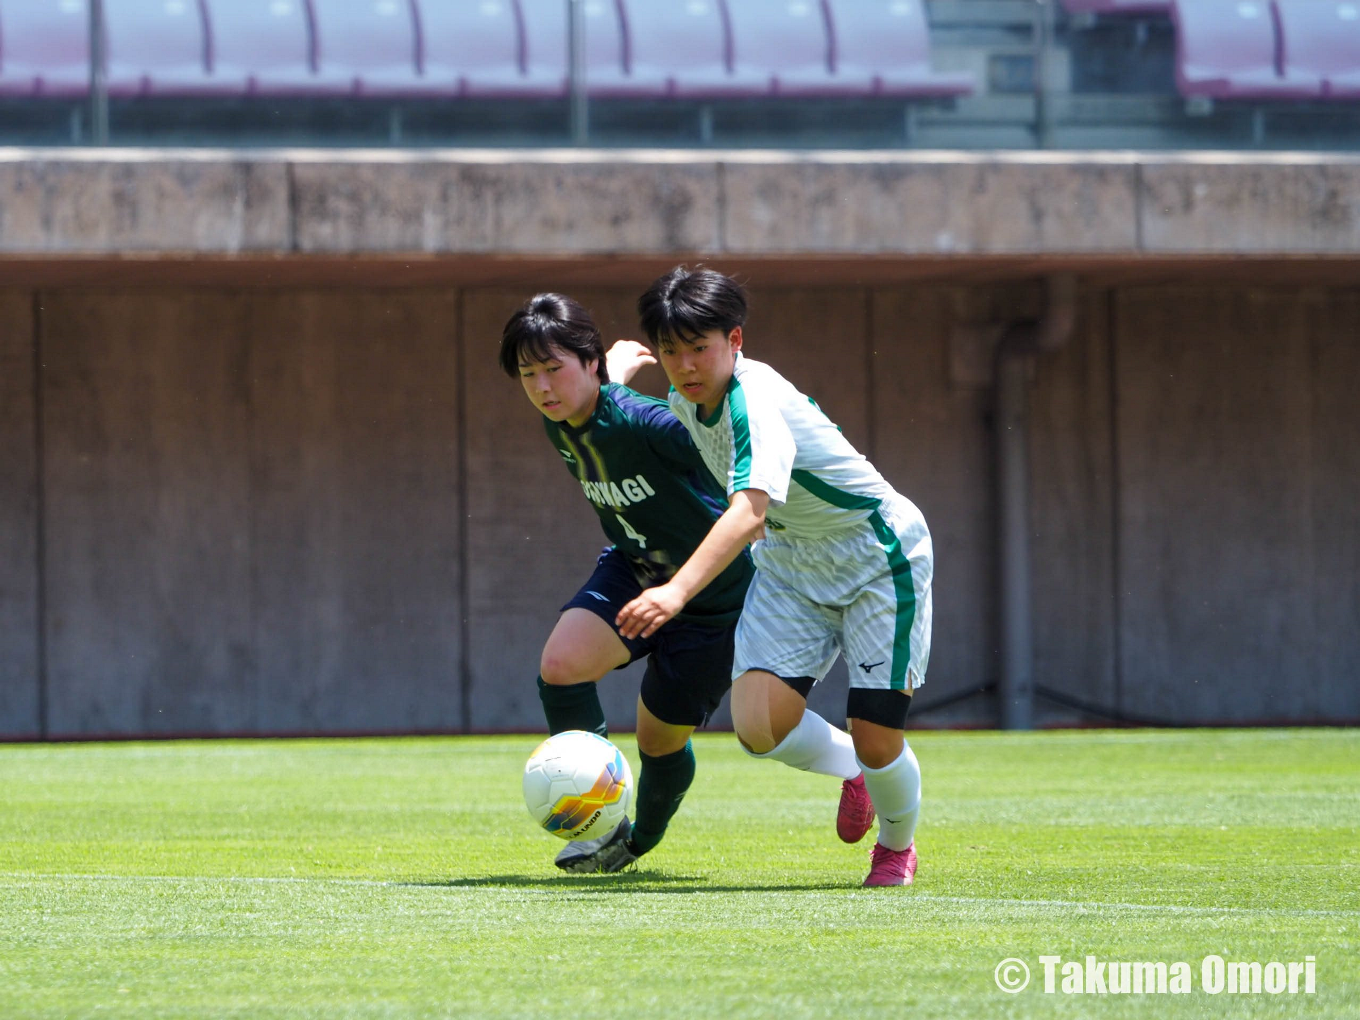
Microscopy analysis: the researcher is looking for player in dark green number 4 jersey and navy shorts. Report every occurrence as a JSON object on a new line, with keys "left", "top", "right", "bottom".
{"left": 500, "top": 294, "right": 752, "bottom": 872}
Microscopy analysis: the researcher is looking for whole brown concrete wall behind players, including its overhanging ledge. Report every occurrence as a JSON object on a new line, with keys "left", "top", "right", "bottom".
{"left": 0, "top": 150, "right": 1360, "bottom": 738}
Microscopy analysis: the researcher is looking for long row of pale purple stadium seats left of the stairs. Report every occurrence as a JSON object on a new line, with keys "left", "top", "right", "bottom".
{"left": 0, "top": 0, "right": 972, "bottom": 99}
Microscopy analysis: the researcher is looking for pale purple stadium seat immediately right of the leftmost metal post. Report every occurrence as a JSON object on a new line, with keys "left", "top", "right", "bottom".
{"left": 103, "top": 0, "right": 209, "bottom": 97}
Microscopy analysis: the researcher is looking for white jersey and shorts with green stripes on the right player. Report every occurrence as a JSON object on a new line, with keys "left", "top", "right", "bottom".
{"left": 670, "top": 352, "right": 934, "bottom": 691}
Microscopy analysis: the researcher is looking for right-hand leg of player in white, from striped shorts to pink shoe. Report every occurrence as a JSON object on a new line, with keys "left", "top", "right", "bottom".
{"left": 842, "top": 500, "right": 933, "bottom": 885}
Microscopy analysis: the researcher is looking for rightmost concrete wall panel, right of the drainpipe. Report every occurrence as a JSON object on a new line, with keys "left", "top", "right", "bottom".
{"left": 1114, "top": 288, "right": 1360, "bottom": 719}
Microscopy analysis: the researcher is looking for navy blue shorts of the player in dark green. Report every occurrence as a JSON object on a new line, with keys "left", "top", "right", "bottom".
{"left": 562, "top": 547, "right": 737, "bottom": 726}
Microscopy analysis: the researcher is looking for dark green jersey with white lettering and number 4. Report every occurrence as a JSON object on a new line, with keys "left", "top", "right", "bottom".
{"left": 544, "top": 382, "right": 753, "bottom": 623}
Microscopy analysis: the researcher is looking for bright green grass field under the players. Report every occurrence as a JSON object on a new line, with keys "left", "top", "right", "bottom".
{"left": 0, "top": 730, "right": 1360, "bottom": 1020}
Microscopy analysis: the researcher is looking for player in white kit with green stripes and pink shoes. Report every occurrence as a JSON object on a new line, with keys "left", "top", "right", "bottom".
{"left": 616, "top": 267, "right": 933, "bottom": 885}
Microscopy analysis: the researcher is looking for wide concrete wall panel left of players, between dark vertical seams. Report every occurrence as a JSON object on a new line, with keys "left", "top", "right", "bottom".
{"left": 23, "top": 291, "right": 462, "bottom": 734}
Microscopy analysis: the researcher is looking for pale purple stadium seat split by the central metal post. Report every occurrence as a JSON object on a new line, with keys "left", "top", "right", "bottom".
{"left": 518, "top": 0, "right": 627, "bottom": 95}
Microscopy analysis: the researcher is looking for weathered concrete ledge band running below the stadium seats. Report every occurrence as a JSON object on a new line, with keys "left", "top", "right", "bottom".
{"left": 0, "top": 150, "right": 1360, "bottom": 257}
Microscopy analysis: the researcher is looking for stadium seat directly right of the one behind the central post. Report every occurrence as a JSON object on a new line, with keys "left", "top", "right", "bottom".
{"left": 609, "top": 0, "right": 732, "bottom": 97}
